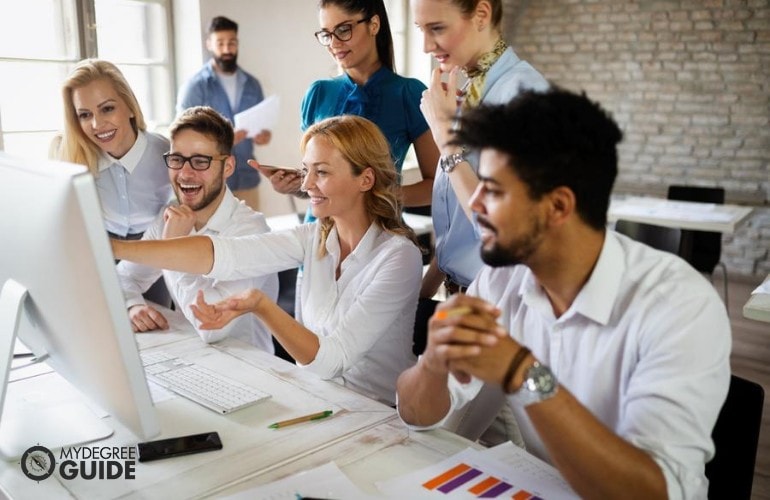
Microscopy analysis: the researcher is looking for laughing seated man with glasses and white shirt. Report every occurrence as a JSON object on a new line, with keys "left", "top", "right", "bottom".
{"left": 117, "top": 106, "right": 278, "bottom": 353}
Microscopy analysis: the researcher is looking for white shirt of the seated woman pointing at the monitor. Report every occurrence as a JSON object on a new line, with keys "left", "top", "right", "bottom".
{"left": 210, "top": 223, "right": 422, "bottom": 404}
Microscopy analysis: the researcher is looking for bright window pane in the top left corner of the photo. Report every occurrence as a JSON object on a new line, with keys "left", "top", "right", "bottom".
{"left": 0, "top": 0, "right": 78, "bottom": 59}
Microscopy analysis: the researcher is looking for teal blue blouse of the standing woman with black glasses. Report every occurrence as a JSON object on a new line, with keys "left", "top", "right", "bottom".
{"left": 301, "top": 66, "right": 428, "bottom": 173}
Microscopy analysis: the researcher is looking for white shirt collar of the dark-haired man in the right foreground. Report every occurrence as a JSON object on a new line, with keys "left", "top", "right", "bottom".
{"left": 518, "top": 231, "right": 625, "bottom": 326}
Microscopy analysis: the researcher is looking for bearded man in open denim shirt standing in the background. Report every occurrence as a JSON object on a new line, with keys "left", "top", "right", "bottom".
{"left": 176, "top": 16, "right": 271, "bottom": 210}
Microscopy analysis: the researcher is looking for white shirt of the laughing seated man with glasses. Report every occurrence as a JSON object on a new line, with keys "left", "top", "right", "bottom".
{"left": 117, "top": 189, "right": 278, "bottom": 353}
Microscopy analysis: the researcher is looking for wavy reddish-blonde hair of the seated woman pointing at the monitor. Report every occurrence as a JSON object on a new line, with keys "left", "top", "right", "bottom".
{"left": 300, "top": 115, "right": 419, "bottom": 257}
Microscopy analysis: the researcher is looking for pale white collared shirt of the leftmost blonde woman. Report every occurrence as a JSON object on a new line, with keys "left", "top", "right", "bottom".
{"left": 96, "top": 130, "right": 174, "bottom": 236}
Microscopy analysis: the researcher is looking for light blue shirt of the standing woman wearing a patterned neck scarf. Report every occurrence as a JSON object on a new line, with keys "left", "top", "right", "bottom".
{"left": 431, "top": 47, "right": 548, "bottom": 286}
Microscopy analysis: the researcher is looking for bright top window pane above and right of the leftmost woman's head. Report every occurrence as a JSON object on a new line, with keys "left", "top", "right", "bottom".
{"left": 95, "top": 0, "right": 168, "bottom": 64}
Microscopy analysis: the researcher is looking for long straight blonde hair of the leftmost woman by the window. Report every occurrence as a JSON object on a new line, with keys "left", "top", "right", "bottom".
{"left": 52, "top": 59, "right": 147, "bottom": 175}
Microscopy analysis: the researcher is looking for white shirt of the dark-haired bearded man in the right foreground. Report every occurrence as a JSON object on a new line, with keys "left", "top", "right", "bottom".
{"left": 404, "top": 231, "right": 731, "bottom": 499}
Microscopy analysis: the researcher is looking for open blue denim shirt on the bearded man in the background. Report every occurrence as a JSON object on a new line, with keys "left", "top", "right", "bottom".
{"left": 176, "top": 60, "right": 264, "bottom": 191}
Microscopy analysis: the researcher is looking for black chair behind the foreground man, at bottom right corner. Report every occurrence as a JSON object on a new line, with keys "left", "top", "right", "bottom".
{"left": 706, "top": 375, "right": 765, "bottom": 500}
